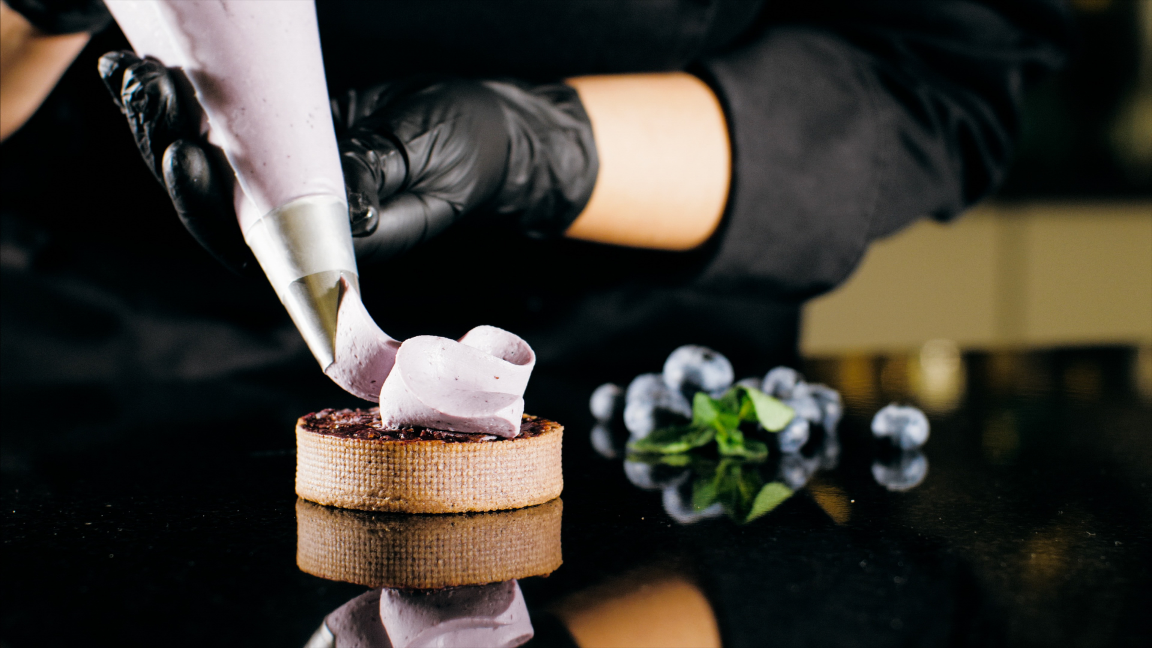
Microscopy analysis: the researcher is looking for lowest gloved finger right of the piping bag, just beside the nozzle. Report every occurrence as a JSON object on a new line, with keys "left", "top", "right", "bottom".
{"left": 353, "top": 194, "right": 456, "bottom": 265}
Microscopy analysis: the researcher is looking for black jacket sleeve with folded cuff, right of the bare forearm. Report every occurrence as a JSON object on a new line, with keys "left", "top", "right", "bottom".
{"left": 696, "top": 0, "right": 1073, "bottom": 299}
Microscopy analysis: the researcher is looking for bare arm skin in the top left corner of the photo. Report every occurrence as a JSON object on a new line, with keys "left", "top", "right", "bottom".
{"left": 0, "top": 2, "right": 92, "bottom": 141}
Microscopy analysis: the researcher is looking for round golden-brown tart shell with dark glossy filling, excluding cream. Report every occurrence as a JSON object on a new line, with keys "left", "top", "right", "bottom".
{"left": 296, "top": 408, "right": 563, "bottom": 513}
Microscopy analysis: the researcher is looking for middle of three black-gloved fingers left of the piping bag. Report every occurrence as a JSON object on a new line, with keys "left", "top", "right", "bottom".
{"left": 120, "top": 59, "right": 199, "bottom": 181}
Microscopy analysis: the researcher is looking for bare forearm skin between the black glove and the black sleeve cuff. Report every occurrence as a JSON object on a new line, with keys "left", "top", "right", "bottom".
{"left": 566, "top": 73, "right": 732, "bottom": 250}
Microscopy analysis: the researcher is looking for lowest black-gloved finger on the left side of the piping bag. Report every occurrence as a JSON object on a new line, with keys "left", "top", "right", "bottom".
{"left": 162, "top": 140, "right": 259, "bottom": 276}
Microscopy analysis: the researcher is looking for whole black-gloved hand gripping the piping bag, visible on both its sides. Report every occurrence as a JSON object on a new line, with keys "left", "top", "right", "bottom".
{"left": 99, "top": 52, "right": 599, "bottom": 270}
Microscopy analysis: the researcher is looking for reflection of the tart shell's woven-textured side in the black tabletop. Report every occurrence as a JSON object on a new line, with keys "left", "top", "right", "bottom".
{"left": 296, "top": 499, "right": 563, "bottom": 589}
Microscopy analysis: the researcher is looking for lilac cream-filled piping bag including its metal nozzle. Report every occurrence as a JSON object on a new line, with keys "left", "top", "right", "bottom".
{"left": 105, "top": 0, "right": 400, "bottom": 401}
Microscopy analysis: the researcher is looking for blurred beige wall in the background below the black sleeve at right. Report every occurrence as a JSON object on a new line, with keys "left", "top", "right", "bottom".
{"left": 801, "top": 202, "right": 1152, "bottom": 356}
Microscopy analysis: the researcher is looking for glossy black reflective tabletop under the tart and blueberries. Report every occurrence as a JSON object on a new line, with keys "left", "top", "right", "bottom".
{"left": 0, "top": 347, "right": 1152, "bottom": 648}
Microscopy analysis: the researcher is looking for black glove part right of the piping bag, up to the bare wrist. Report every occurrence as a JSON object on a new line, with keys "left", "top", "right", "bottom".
{"left": 333, "top": 78, "right": 599, "bottom": 263}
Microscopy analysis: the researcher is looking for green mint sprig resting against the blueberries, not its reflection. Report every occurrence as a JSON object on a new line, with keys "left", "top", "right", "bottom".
{"left": 628, "top": 385, "right": 796, "bottom": 461}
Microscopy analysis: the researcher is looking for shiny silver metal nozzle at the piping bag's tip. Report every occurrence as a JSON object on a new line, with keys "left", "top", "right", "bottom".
{"left": 244, "top": 195, "right": 359, "bottom": 369}
